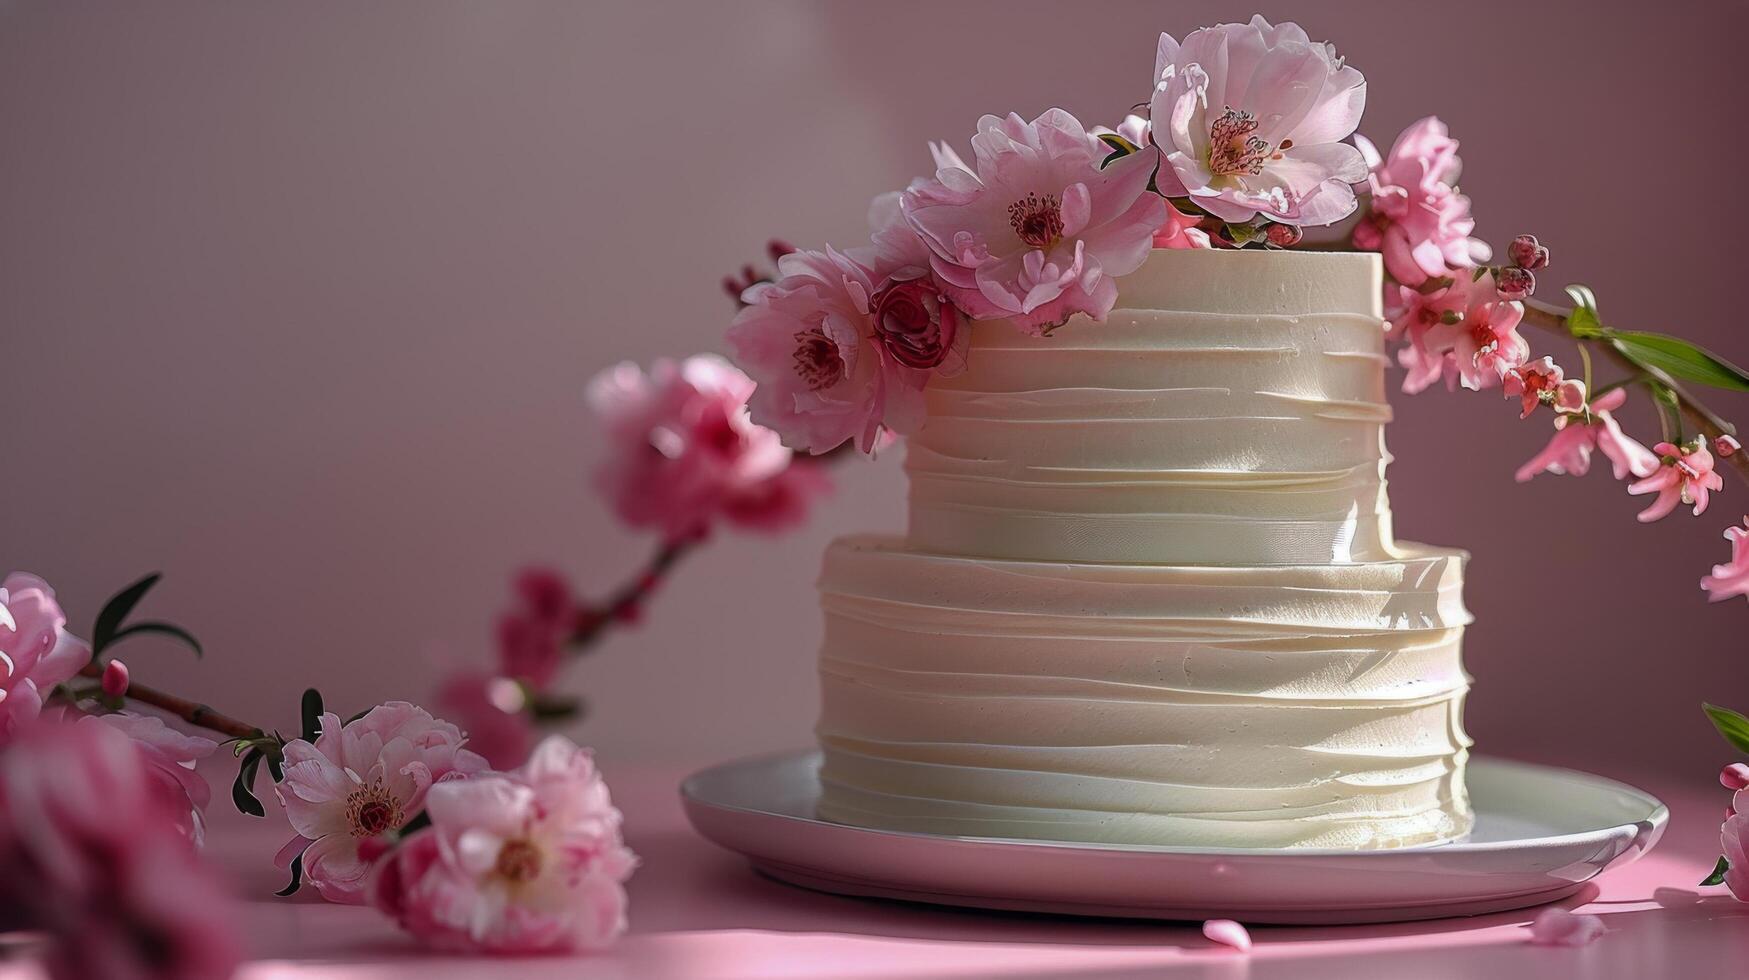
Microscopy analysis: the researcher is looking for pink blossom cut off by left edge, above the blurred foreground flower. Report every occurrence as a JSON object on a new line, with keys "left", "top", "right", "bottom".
{"left": 0, "top": 572, "right": 91, "bottom": 744}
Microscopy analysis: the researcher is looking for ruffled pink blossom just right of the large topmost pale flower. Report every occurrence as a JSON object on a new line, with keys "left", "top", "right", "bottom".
{"left": 1354, "top": 116, "right": 1488, "bottom": 285}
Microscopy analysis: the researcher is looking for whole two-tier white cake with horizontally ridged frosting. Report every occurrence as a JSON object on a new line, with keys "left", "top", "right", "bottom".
{"left": 819, "top": 249, "right": 1473, "bottom": 849}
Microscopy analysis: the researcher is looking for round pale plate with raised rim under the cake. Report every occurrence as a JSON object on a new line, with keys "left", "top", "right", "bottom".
{"left": 680, "top": 751, "right": 1670, "bottom": 924}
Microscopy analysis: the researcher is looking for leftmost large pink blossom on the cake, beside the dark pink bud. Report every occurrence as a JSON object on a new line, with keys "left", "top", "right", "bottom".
{"left": 728, "top": 247, "right": 929, "bottom": 453}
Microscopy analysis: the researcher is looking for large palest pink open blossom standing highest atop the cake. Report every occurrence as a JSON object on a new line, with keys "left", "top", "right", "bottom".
{"left": 1149, "top": 16, "right": 1366, "bottom": 224}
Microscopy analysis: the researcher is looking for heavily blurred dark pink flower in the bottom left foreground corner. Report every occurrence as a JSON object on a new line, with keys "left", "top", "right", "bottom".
{"left": 0, "top": 723, "right": 240, "bottom": 980}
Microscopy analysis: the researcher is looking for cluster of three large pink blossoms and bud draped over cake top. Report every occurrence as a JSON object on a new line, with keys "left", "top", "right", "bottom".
{"left": 729, "top": 18, "right": 1368, "bottom": 453}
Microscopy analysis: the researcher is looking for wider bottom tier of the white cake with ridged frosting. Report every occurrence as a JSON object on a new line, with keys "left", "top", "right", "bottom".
{"left": 817, "top": 536, "right": 1473, "bottom": 849}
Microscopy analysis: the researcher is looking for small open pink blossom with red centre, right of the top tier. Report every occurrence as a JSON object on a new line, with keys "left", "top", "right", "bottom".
{"left": 1397, "top": 273, "right": 1530, "bottom": 394}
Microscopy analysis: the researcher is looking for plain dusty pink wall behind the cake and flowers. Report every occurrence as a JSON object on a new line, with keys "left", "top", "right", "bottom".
{"left": 0, "top": 2, "right": 1749, "bottom": 777}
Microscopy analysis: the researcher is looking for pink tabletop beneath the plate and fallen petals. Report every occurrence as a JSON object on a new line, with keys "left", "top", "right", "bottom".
{"left": 13, "top": 752, "right": 1749, "bottom": 980}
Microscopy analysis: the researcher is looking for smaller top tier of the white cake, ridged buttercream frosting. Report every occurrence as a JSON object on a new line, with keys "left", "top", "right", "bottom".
{"left": 906, "top": 250, "right": 1392, "bottom": 565}
